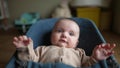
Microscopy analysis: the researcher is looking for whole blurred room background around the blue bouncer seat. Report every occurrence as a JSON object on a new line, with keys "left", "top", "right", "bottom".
{"left": 0, "top": 0, "right": 120, "bottom": 68}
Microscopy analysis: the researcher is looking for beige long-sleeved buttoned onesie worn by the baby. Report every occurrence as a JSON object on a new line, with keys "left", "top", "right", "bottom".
{"left": 17, "top": 45, "right": 97, "bottom": 67}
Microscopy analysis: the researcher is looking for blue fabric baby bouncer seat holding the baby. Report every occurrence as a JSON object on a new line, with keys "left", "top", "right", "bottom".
{"left": 6, "top": 18, "right": 120, "bottom": 68}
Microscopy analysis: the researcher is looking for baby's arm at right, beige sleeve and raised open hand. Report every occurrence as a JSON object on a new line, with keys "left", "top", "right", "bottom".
{"left": 82, "top": 43, "right": 116, "bottom": 66}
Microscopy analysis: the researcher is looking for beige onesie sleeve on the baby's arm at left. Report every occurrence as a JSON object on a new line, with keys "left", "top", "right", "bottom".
{"left": 17, "top": 46, "right": 41, "bottom": 62}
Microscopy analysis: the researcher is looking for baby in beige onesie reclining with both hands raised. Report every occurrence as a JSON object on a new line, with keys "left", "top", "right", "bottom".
{"left": 13, "top": 18, "right": 116, "bottom": 67}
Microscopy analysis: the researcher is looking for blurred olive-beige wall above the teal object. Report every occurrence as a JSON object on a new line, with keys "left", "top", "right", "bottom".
{"left": 8, "top": 0, "right": 61, "bottom": 21}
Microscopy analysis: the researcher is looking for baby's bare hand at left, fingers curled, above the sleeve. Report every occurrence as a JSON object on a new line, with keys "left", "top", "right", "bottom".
{"left": 13, "top": 36, "right": 33, "bottom": 48}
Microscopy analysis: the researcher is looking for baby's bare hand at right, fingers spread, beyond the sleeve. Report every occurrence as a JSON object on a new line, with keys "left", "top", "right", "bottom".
{"left": 92, "top": 43, "right": 116, "bottom": 61}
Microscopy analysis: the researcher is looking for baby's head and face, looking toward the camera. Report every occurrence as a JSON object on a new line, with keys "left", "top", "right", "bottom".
{"left": 51, "top": 19, "right": 80, "bottom": 48}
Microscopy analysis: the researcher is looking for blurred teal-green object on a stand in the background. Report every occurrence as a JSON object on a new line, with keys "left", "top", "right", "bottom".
{"left": 14, "top": 12, "right": 40, "bottom": 33}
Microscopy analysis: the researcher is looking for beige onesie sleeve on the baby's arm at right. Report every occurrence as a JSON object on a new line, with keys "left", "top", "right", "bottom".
{"left": 79, "top": 49, "right": 98, "bottom": 67}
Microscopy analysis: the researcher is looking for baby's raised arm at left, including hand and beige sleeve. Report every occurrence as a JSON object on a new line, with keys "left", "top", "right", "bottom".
{"left": 13, "top": 36, "right": 39, "bottom": 62}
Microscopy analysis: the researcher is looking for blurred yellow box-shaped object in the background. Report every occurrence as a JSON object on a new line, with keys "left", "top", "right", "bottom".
{"left": 77, "top": 7, "right": 100, "bottom": 27}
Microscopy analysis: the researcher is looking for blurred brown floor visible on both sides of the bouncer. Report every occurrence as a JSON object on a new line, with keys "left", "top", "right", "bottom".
{"left": 0, "top": 28, "right": 120, "bottom": 68}
